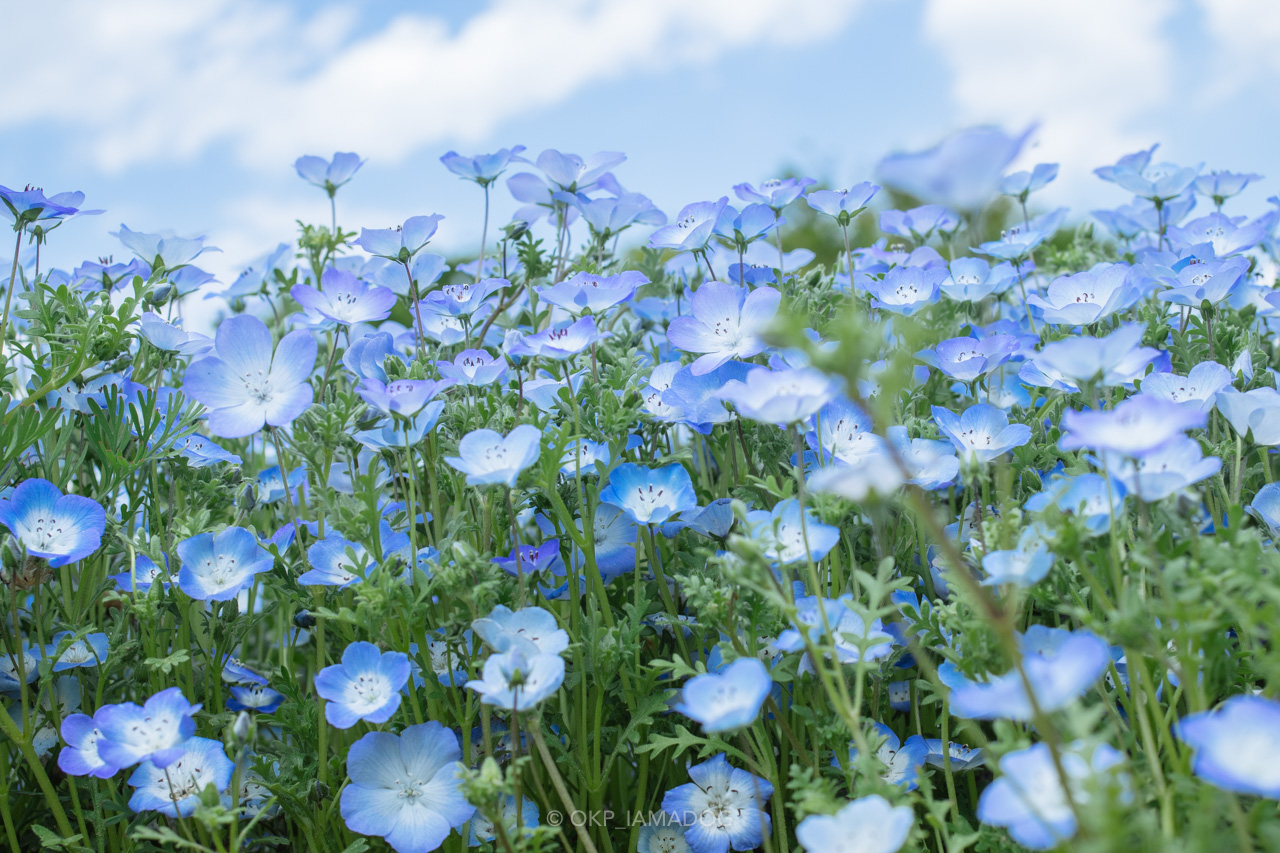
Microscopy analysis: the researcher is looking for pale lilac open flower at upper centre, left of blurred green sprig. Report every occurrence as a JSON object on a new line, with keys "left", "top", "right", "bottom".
{"left": 667, "top": 282, "right": 782, "bottom": 375}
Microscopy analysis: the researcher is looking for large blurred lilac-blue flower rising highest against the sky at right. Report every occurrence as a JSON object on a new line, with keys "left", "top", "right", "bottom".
{"left": 876, "top": 127, "right": 1034, "bottom": 210}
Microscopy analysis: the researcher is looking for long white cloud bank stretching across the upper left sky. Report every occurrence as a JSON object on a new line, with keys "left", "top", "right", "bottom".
{"left": 0, "top": 0, "right": 861, "bottom": 170}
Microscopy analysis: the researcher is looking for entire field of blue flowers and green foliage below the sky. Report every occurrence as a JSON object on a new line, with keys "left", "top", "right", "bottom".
{"left": 0, "top": 129, "right": 1280, "bottom": 853}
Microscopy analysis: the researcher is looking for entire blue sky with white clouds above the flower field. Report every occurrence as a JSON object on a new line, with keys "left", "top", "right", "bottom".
{"left": 0, "top": 0, "right": 1280, "bottom": 282}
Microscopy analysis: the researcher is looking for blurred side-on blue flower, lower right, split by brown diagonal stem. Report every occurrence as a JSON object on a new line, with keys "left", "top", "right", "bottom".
{"left": 951, "top": 625, "right": 1111, "bottom": 721}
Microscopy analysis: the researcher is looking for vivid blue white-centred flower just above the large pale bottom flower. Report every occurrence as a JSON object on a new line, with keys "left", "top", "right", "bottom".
{"left": 316, "top": 640, "right": 410, "bottom": 729}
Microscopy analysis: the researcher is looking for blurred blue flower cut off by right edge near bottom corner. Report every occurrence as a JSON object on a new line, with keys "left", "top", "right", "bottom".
{"left": 1174, "top": 695, "right": 1280, "bottom": 799}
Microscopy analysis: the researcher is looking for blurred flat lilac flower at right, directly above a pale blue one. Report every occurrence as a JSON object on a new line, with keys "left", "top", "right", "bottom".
{"left": 1059, "top": 394, "right": 1203, "bottom": 457}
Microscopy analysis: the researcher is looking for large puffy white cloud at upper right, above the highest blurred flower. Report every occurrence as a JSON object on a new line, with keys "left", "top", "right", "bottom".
{"left": 924, "top": 0, "right": 1177, "bottom": 196}
